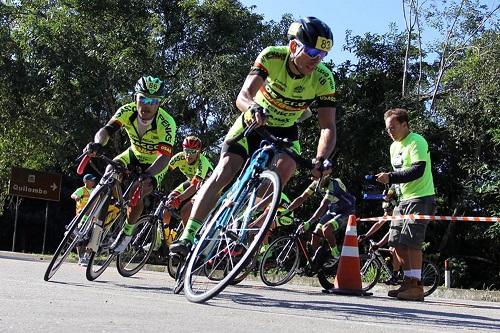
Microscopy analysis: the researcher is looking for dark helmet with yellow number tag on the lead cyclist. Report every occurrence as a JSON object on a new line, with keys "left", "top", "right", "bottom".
{"left": 288, "top": 16, "right": 333, "bottom": 52}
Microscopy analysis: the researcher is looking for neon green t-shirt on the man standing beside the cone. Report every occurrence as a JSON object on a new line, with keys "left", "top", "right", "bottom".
{"left": 390, "top": 132, "right": 435, "bottom": 200}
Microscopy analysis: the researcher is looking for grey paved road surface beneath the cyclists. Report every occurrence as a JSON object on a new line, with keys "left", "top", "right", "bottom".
{"left": 0, "top": 258, "right": 500, "bottom": 333}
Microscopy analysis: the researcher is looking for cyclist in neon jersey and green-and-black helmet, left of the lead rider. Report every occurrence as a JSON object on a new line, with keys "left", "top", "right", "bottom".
{"left": 85, "top": 76, "right": 177, "bottom": 253}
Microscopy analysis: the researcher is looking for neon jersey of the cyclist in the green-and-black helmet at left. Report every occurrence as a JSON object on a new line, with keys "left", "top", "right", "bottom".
{"left": 108, "top": 102, "right": 177, "bottom": 164}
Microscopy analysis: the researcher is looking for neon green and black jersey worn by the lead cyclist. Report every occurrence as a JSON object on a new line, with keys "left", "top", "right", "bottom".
{"left": 250, "top": 46, "right": 336, "bottom": 127}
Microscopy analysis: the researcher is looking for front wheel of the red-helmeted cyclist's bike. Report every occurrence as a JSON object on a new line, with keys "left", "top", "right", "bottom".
{"left": 116, "top": 215, "right": 158, "bottom": 277}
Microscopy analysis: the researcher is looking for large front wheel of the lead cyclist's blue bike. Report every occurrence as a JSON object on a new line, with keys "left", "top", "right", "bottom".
{"left": 184, "top": 170, "right": 281, "bottom": 302}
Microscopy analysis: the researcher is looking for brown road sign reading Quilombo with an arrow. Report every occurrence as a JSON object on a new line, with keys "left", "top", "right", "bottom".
{"left": 9, "top": 167, "right": 61, "bottom": 201}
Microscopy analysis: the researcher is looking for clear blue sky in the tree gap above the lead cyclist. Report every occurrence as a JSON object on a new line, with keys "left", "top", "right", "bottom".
{"left": 240, "top": 0, "right": 405, "bottom": 64}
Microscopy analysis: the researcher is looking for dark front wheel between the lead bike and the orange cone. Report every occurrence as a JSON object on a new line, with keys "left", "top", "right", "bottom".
{"left": 259, "top": 236, "right": 300, "bottom": 287}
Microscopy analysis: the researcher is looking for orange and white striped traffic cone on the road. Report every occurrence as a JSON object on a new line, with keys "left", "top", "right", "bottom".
{"left": 328, "top": 215, "right": 371, "bottom": 296}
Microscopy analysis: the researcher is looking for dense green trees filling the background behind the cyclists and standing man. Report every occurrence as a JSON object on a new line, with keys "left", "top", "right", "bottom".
{"left": 0, "top": 0, "right": 500, "bottom": 286}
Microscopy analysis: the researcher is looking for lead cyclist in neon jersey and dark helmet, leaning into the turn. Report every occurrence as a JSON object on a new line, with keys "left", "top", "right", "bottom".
{"left": 170, "top": 17, "right": 336, "bottom": 255}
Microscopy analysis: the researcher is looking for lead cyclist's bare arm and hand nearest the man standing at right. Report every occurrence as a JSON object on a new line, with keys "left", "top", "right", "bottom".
{"left": 312, "top": 107, "right": 337, "bottom": 178}
